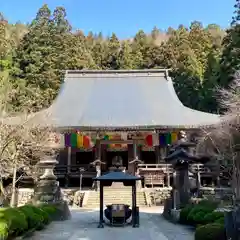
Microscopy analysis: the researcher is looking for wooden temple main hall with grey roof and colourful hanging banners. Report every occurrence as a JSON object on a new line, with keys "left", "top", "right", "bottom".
{"left": 10, "top": 69, "right": 220, "bottom": 188}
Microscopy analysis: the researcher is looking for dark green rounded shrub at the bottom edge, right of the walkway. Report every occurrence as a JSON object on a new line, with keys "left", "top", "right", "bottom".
{"left": 195, "top": 223, "right": 226, "bottom": 240}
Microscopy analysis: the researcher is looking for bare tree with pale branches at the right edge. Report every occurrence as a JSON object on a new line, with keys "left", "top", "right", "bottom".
{"left": 197, "top": 75, "right": 240, "bottom": 201}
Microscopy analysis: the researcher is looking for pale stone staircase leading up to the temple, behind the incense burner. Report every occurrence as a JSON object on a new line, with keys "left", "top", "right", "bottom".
{"left": 84, "top": 186, "right": 147, "bottom": 208}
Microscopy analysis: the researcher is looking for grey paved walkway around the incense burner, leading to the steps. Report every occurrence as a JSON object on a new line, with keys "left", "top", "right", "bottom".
{"left": 29, "top": 207, "right": 194, "bottom": 240}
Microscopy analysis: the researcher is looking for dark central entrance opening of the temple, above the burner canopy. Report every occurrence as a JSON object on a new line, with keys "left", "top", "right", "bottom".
{"left": 106, "top": 151, "right": 128, "bottom": 170}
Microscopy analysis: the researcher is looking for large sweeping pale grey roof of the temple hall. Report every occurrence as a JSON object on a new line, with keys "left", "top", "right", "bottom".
{"left": 6, "top": 69, "right": 220, "bottom": 130}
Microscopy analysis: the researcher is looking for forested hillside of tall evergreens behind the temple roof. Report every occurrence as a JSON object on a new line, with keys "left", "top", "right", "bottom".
{"left": 0, "top": 0, "right": 240, "bottom": 112}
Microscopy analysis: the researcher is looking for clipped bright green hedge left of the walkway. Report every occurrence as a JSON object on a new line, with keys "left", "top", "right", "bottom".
{"left": 0, "top": 205, "right": 57, "bottom": 240}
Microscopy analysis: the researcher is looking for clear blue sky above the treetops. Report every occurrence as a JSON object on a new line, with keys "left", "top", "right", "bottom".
{"left": 0, "top": 0, "right": 235, "bottom": 38}
